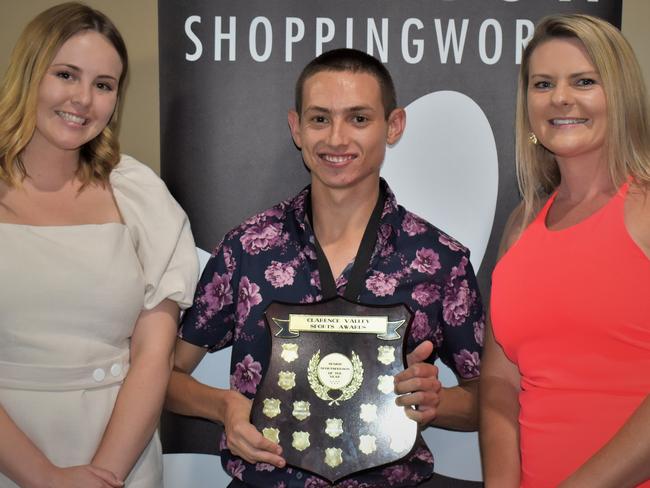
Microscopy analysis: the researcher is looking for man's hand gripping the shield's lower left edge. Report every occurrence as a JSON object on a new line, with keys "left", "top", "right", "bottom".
{"left": 223, "top": 390, "right": 286, "bottom": 468}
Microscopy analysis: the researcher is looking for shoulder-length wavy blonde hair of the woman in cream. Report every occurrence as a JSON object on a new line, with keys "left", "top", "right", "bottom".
{"left": 0, "top": 2, "right": 128, "bottom": 186}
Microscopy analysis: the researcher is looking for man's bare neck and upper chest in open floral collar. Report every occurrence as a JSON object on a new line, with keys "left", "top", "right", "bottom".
{"left": 311, "top": 179, "right": 379, "bottom": 279}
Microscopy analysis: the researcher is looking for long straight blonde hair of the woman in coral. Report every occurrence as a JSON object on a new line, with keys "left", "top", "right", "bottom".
{"left": 515, "top": 14, "right": 650, "bottom": 224}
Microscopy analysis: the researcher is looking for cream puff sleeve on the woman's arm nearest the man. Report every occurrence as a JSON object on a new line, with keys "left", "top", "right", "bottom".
{"left": 110, "top": 155, "right": 198, "bottom": 310}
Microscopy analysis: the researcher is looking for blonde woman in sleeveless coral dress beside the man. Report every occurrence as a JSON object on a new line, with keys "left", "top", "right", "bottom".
{"left": 481, "top": 15, "right": 650, "bottom": 488}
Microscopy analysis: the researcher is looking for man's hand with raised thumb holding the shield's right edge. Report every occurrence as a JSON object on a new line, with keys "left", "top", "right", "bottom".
{"left": 395, "top": 341, "right": 442, "bottom": 427}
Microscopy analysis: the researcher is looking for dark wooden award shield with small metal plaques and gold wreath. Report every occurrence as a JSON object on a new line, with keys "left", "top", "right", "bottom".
{"left": 251, "top": 297, "right": 418, "bottom": 482}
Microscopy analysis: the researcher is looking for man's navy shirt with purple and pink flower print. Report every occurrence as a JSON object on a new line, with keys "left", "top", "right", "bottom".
{"left": 179, "top": 180, "right": 485, "bottom": 488}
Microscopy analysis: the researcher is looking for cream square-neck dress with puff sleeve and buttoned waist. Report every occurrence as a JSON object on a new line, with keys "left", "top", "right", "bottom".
{"left": 0, "top": 156, "right": 198, "bottom": 488}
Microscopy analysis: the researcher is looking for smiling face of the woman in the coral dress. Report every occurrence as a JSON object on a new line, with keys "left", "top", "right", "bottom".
{"left": 527, "top": 38, "right": 607, "bottom": 166}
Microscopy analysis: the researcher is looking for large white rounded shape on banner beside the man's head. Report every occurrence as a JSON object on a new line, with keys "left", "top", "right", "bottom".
{"left": 382, "top": 91, "right": 499, "bottom": 272}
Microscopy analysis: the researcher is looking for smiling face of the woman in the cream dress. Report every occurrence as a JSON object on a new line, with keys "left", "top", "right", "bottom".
{"left": 29, "top": 31, "right": 122, "bottom": 158}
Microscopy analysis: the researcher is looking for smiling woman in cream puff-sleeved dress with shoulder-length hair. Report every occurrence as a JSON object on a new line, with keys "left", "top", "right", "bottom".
{"left": 0, "top": 3, "right": 197, "bottom": 488}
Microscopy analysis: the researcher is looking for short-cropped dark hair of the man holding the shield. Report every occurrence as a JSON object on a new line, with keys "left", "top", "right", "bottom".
{"left": 295, "top": 48, "right": 397, "bottom": 119}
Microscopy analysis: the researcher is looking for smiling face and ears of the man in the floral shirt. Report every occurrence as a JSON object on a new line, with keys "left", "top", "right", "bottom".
{"left": 289, "top": 71, "right": 405, "bottom": 196}
